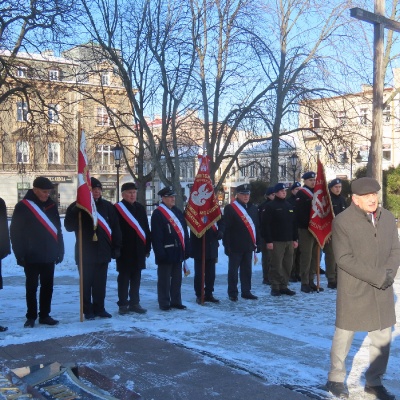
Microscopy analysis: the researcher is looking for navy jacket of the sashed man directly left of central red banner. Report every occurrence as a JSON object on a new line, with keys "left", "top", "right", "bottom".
{"left": 151, "top": 206, "right": 190, "bottom": 265}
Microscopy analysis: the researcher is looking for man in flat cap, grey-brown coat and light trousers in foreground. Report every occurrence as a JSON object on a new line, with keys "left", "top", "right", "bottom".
{"left": 326, "top": 178, "right": 400, "bottom": 400}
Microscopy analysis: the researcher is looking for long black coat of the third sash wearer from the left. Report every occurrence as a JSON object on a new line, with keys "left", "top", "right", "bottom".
{"left": 114, "top": 200, "right": 151, "bottom": 271}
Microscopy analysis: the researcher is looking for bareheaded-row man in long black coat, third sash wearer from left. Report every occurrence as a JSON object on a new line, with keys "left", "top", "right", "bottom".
{"left": 114, "top": 182, "right": 151, "bottom": 314}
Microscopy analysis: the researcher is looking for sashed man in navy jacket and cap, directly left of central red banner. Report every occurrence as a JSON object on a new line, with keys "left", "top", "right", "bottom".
{"left": 151, "top": 186, "right": 190, "bottom": 311}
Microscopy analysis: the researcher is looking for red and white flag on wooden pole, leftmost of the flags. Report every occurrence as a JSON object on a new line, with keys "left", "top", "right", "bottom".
{"left": 76, "top": 131, "right": 97, "bottom": 229}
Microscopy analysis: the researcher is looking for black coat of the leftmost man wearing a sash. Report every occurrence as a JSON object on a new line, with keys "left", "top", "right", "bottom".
{"left": 10, "top": 189, "right": 64, "bottom": 266}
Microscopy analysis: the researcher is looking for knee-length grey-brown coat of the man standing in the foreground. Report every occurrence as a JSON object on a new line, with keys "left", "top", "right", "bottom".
{"left": 332, "top": 203, "right": 400, "bottom": 331}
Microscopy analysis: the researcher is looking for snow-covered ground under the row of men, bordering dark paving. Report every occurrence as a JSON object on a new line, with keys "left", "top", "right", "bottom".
{"left": 0, "top": 222, "right": 400, "bottom": 399}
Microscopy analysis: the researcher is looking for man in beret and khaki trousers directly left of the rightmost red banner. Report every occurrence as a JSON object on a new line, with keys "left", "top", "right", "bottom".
{"left": 295, "top": 171, "right": 324, "bottom": 293}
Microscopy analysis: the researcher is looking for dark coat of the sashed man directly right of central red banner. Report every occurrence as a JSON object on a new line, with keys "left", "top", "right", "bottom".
{"left": 222, "top": 201, "right": 261, "bottom": 255}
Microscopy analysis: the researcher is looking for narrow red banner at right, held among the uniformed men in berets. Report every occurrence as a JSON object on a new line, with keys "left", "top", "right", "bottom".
{"left": 308, "top": 159, "right": 334, "bottom": 247}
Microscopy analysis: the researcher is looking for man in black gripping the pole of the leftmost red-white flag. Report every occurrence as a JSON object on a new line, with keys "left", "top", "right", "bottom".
{"left": 64, "top": 178, "right": 122, "bottom": 320}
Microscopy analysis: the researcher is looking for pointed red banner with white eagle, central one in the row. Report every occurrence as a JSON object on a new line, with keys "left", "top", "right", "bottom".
{"left": 185, "top": 156, "right": 221, "bottom": 238}
